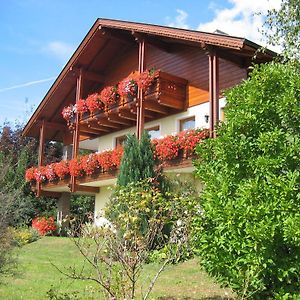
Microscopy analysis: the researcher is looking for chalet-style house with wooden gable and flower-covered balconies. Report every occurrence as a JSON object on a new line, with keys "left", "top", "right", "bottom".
{"left": 23, "top": 19, "right": 274, "bottom": 225}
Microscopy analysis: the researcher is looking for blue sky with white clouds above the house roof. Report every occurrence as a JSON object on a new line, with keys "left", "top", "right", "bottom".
{"left": 0, "top": 0, "right": 280, "bottom": 124}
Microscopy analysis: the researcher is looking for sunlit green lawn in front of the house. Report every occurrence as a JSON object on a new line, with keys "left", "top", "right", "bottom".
{"left": 0, "top": 237, "right": 232, "bottom": 300}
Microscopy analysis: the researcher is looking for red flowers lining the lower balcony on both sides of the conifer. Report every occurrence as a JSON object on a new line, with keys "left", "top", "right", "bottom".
{"left": 25, "top": 129, "right": 209, "bottom": 184}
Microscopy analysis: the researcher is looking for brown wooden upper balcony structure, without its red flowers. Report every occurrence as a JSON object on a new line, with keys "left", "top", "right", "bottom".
{"left": 79, "top": 70, "right": 188, "bottom": 137}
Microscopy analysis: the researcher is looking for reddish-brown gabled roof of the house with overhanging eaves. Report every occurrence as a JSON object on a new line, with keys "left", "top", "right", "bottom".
{"left": 23, "top": 19, "right": 276, "bottom": 140}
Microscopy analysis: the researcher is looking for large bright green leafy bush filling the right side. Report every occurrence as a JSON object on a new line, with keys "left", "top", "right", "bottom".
{"left": 194, "top": 63, "right": 300, "bottom": 299}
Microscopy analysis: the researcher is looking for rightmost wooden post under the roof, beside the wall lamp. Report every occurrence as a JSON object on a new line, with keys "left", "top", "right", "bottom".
{"left": 208, "top": 51, "right": 220, "bottom": 138}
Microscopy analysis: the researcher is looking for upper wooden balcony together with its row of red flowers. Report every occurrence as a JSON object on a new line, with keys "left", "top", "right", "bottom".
{"left": 62, "top": 70, "right": 187, "bottom": 136}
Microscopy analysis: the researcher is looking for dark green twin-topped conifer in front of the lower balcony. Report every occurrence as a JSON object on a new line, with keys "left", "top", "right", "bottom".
{"left": 117, "top": 131, "right": 155, "bottom": 186}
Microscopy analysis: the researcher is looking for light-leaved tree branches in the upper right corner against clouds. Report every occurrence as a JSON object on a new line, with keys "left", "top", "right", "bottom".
{"left": 263, "top": 0, "right": 300, "bottom": 60}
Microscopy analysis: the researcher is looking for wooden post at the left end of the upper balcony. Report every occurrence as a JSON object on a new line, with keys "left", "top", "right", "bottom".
{"left": 71, "top": 69, "right": 82, "bottom": 193}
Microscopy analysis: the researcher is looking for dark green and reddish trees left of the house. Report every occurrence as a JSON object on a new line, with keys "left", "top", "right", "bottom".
{"left": 0, "top": 124, "right": 60, "bottom": 226}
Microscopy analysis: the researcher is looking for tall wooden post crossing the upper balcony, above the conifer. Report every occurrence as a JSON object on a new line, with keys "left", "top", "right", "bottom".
{"left": 136, "top": 39, "right": 146, "bottom": 140}
